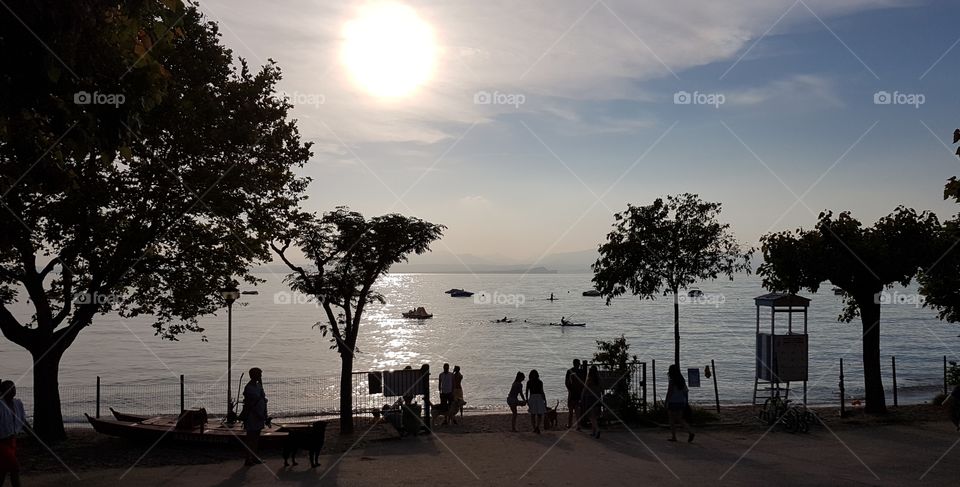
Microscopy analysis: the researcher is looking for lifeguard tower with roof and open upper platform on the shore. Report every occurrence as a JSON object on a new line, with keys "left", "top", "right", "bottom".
{"left": 753, "top": 293, "right": 810, "bottom": 405}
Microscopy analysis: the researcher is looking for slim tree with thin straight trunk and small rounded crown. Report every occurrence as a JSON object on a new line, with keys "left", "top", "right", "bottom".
{"left": 593, "top": 193, "right": 753, "bottom": 366}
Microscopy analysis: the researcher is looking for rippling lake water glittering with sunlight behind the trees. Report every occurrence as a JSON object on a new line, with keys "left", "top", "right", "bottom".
{"left": 0, "top": 274, "right": 960, "bottom": 422}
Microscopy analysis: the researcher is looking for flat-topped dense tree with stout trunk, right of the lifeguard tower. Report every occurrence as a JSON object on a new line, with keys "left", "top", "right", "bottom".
{"left": 758, "top": 207, "right": 940, "bottom": 413}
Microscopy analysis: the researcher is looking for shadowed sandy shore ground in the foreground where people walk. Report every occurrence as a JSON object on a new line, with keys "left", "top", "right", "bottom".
{"left": 21, "top": 406, "right": 960, "bottom": 486}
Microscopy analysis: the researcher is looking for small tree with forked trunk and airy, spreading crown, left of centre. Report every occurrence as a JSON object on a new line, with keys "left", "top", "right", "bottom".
{"left": 274, "top": 207, "right": 446, "bottom": 434}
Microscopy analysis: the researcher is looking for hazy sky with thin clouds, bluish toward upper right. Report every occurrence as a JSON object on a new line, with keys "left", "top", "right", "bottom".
{"left": 200, "top": 0, "right": 960, "bottom": 261}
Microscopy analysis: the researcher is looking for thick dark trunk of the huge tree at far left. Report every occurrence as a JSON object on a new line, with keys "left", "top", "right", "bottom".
{"left": 31, "top": 347, "right": 67, "bottom": 442}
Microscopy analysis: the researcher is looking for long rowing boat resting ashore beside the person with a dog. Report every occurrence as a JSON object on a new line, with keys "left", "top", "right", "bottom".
{"left": 85, "top": 408, "right": 288, "bottom": 448}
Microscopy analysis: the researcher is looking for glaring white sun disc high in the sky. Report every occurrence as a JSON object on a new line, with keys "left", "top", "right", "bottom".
{"left": 341, "top": 3, "right": 436, "bottom": 98}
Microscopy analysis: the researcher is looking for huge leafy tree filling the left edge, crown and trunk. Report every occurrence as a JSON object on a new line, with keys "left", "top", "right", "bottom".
{"left": 0, "top": 0, "right": 310, "bottom": 440}
